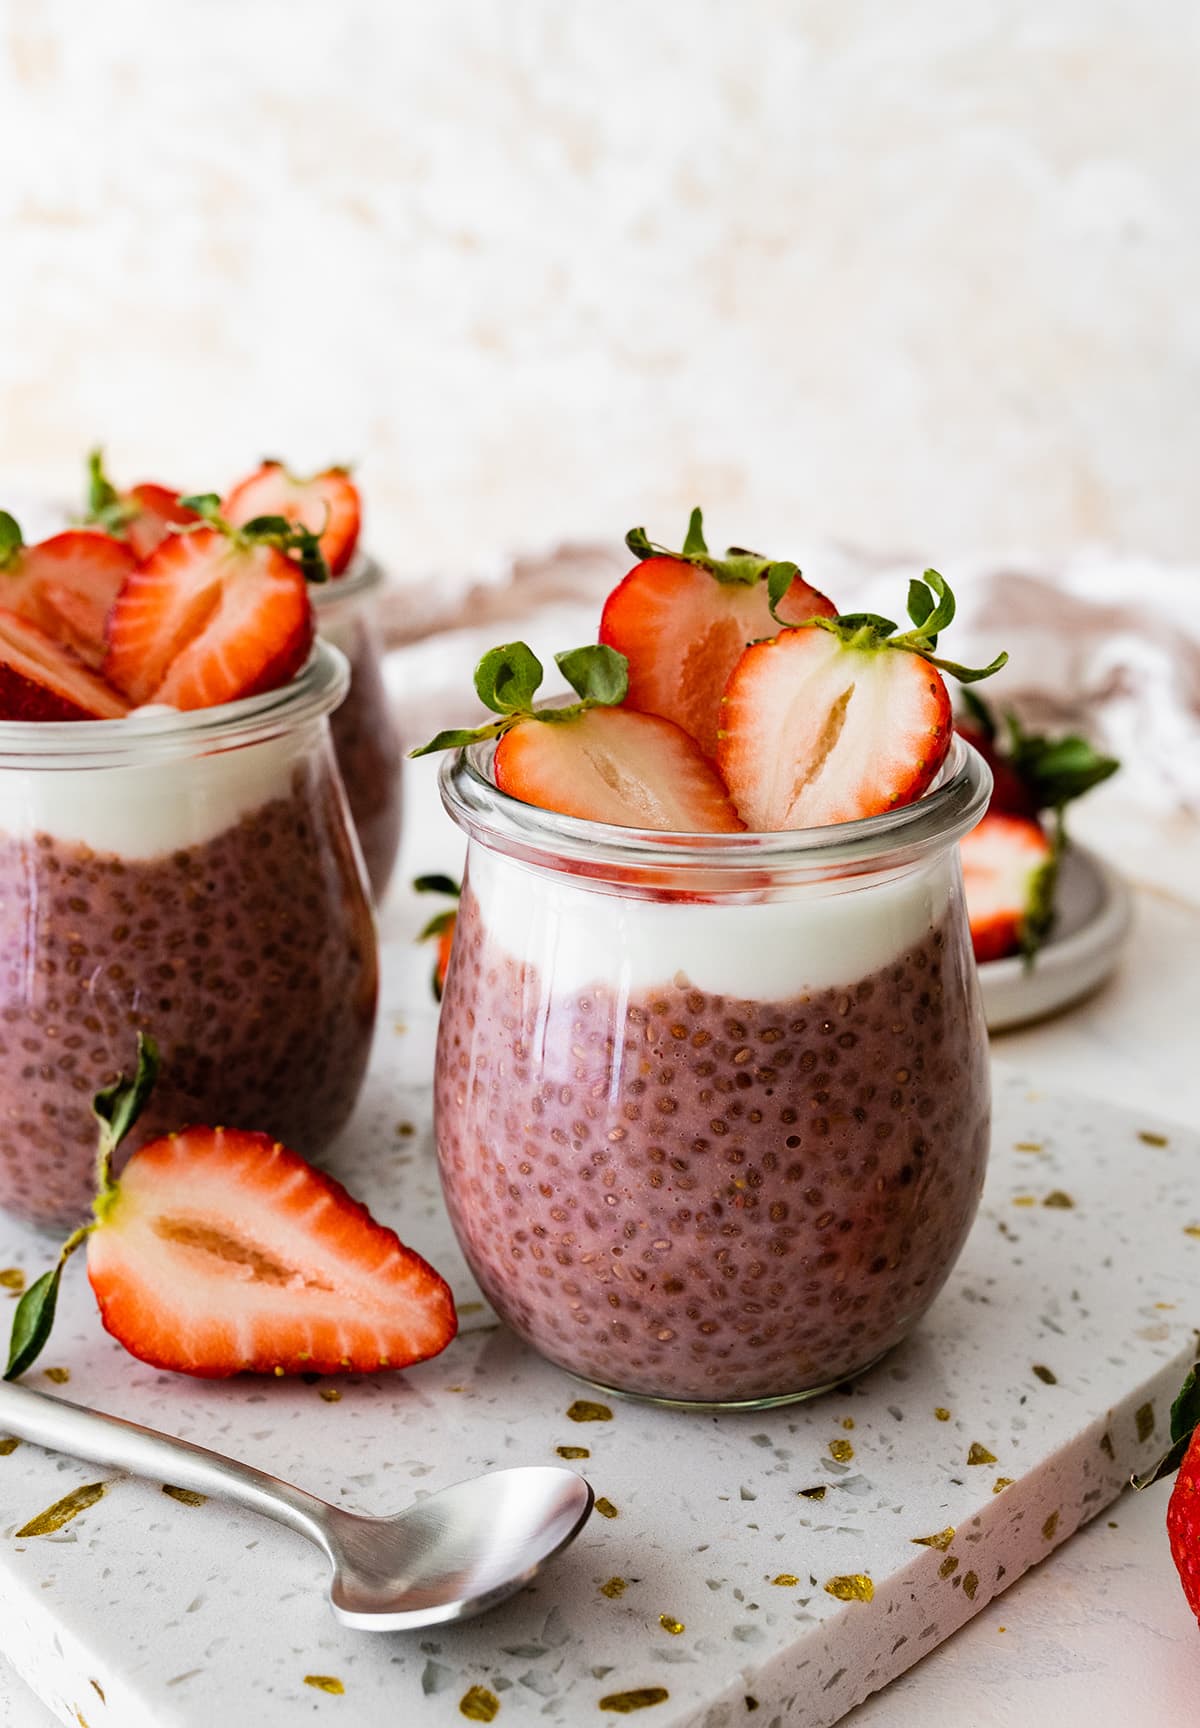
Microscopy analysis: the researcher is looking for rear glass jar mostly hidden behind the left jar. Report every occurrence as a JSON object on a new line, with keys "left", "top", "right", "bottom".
{"left": 310, "top": 553, "right": 401, "bottom": 904}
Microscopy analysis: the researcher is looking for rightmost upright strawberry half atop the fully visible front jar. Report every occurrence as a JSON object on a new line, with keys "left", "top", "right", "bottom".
{"left": 718, "top": 567, "right": 1008, "bottom": 831}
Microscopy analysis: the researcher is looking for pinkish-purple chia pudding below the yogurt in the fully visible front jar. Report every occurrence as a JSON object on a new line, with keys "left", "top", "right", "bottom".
{"left": 436, "top": 885, "right": 991, "bottom": 1403}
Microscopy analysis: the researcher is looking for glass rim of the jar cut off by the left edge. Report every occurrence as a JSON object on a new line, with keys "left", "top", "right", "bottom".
{"left": 0, "top": 638, "right": 349, "bottom": 771}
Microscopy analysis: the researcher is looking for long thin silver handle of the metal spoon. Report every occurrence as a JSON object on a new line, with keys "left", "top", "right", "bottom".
{"left": 0, "top": 1381, "right": 334, "bottom": 1553}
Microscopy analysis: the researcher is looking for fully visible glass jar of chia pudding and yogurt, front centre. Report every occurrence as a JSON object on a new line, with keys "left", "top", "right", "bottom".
{"left": 436, "top": 740, "right": 991, "bottom": 1407}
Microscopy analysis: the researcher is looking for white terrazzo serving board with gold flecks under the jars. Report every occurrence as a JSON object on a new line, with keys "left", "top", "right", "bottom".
{"left": 0, "top": 943, "right": 1200, "bottom": 1728}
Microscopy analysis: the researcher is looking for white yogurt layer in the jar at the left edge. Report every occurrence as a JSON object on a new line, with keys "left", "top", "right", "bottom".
{"left": 0, "top": 722, "right": 313, "bottom": 859}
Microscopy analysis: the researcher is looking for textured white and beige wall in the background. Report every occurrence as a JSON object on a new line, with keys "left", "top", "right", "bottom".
{"left": 0, "top": 0, "right": 1200, "bottom": 569}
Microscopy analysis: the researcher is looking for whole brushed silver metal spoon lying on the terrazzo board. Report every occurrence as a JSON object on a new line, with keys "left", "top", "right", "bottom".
{"left": 0, "top": 1382, "right": 593, "bottom": 1631}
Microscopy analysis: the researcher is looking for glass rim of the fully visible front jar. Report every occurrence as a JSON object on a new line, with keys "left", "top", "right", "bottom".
{"left": 439, "top": 734, "right": 993, "bottom": 890}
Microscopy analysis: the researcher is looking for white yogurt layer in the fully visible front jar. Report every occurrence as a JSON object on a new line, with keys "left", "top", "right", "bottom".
{"left": 469, "top": 845, "right": 954, "bottom": 1001}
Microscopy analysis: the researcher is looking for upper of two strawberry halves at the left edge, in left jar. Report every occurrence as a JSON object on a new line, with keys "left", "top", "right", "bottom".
{"left": 0, "top": 510, "right": 137, "bottom": 669}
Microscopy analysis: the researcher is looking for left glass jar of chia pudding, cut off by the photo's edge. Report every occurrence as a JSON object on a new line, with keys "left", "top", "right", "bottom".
{"left": 0, "top": 645, "right": 379, "bottom": 1227}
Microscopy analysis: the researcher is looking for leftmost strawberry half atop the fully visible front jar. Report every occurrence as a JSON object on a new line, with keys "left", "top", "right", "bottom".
{"left": 412, "top": 643, "right": 742, "bottom": 835}
